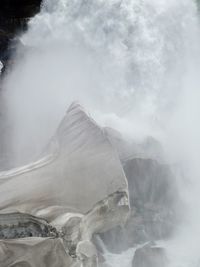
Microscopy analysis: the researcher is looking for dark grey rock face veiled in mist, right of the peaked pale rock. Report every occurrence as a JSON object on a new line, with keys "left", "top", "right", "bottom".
{"left": 99, "top": 158, "right": 179, "bottom": 252}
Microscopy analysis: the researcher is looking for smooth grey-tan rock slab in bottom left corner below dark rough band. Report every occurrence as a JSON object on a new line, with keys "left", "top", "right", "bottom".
{"left": 0, "top": 238, "right": 74, "bottom": 267}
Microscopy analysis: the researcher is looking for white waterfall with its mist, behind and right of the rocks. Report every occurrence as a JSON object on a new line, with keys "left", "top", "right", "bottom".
{"left": 4, "top": 0, "right": 200, "bottom": 267}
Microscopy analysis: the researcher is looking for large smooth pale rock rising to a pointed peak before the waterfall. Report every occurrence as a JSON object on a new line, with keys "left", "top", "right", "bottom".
{"left": 0, "top": 104, "right": 129, "bottom": 267}
